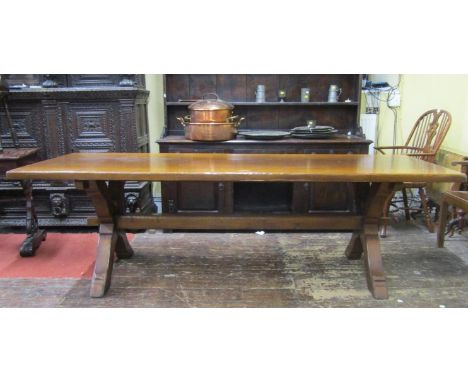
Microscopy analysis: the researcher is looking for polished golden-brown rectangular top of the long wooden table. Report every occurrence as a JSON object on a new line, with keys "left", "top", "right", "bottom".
{"left": 7, "top": 153, "right": 466, "bottom": 182}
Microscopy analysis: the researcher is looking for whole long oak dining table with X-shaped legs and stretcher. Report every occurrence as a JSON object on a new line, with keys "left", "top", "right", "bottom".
{"left": 7, "top": 153, "right": 466, "bottom": 299}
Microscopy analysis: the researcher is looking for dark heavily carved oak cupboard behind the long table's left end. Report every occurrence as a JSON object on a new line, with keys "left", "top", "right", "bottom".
{"left": 0, "top": 74, "right": 154, "bottom": 226}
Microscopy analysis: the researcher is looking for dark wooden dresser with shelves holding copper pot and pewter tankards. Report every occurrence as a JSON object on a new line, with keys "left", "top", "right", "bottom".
{"left": 158, "top": 74, "right": 371, "bottom": 218}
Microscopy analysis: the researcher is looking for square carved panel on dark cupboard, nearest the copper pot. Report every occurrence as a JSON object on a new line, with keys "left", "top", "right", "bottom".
{"left": 67, "top": 104, "right": 116, "bottom": 152}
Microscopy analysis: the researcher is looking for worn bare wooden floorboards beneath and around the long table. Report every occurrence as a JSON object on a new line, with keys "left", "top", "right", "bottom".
{"left": 0, "top": 223, "right": 468, "bottom": 308}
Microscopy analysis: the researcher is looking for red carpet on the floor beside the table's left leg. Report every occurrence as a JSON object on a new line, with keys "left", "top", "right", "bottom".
{"left": 0, "top": 233, "right": 133, "bottom": 279}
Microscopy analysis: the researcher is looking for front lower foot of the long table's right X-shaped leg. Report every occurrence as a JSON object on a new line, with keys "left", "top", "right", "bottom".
{"left": 361, "top": 224, "right": 388, "bottom": 300}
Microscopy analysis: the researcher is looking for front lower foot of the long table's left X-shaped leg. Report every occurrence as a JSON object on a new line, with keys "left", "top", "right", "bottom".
{"left": 90, "top": 224, "right": 117, "bottom": 297}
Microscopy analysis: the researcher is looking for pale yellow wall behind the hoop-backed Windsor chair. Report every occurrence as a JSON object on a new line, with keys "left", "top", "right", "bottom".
{"left": 372, "top": 74, "right": 468, "bottom": 155}
